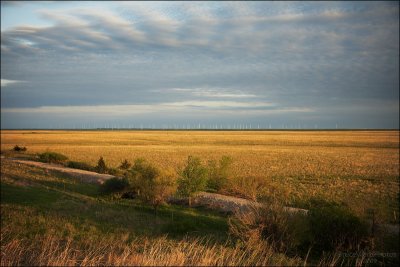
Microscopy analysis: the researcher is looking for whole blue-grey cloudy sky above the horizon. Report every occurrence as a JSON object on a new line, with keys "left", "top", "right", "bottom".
{"left": 1, "top": 1, "right": 399, "bottom": 129}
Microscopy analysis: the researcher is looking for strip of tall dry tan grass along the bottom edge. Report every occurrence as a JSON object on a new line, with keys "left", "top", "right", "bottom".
{"left": 1, "top": 230, "right": 301, "bottom": 266}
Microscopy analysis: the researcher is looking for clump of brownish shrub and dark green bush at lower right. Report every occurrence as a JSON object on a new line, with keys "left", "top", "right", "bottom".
{"left": 229, "top": 199, "right": 369, "bottom": 257}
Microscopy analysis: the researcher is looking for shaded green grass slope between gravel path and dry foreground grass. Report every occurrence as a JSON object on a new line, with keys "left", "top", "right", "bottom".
{"left": 1, "top": 162, "right": 228, "bottom": 244}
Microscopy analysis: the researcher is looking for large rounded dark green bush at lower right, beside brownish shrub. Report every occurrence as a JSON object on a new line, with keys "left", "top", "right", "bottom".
{"left": 309, "top": 199, "right": 368, "bottom": 252}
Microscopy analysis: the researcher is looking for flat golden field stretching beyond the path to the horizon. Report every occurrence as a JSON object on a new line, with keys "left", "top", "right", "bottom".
{"left": 1, "top": 130, "right": 399, "bottom": 222}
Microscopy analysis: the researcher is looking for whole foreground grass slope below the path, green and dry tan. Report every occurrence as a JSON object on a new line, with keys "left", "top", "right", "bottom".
{"left": 1, "top": 161, "right": 300, "bottom": 266}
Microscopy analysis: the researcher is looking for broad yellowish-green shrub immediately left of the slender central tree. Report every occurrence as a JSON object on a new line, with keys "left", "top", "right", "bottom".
{"left": 128, "top": 159, "right": 176, "bottom": 211}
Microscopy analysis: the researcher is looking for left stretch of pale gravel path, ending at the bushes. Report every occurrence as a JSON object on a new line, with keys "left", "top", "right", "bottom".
{"left": 1, "top": 157, "right": 115, "bottom": 184}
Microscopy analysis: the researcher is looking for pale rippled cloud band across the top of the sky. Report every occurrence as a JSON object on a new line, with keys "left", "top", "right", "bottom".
{"left": 2, "top": 3, "right": 396, "bottom": 56}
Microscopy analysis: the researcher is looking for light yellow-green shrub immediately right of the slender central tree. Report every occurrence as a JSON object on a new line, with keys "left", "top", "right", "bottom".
{"left": 207, "top": 156, "right": 232, "bottom": 192}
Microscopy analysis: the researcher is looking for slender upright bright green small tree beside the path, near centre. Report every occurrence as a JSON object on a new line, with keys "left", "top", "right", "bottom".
{"left": 178, "top": 156, "right": 207, "bottom": 206}
